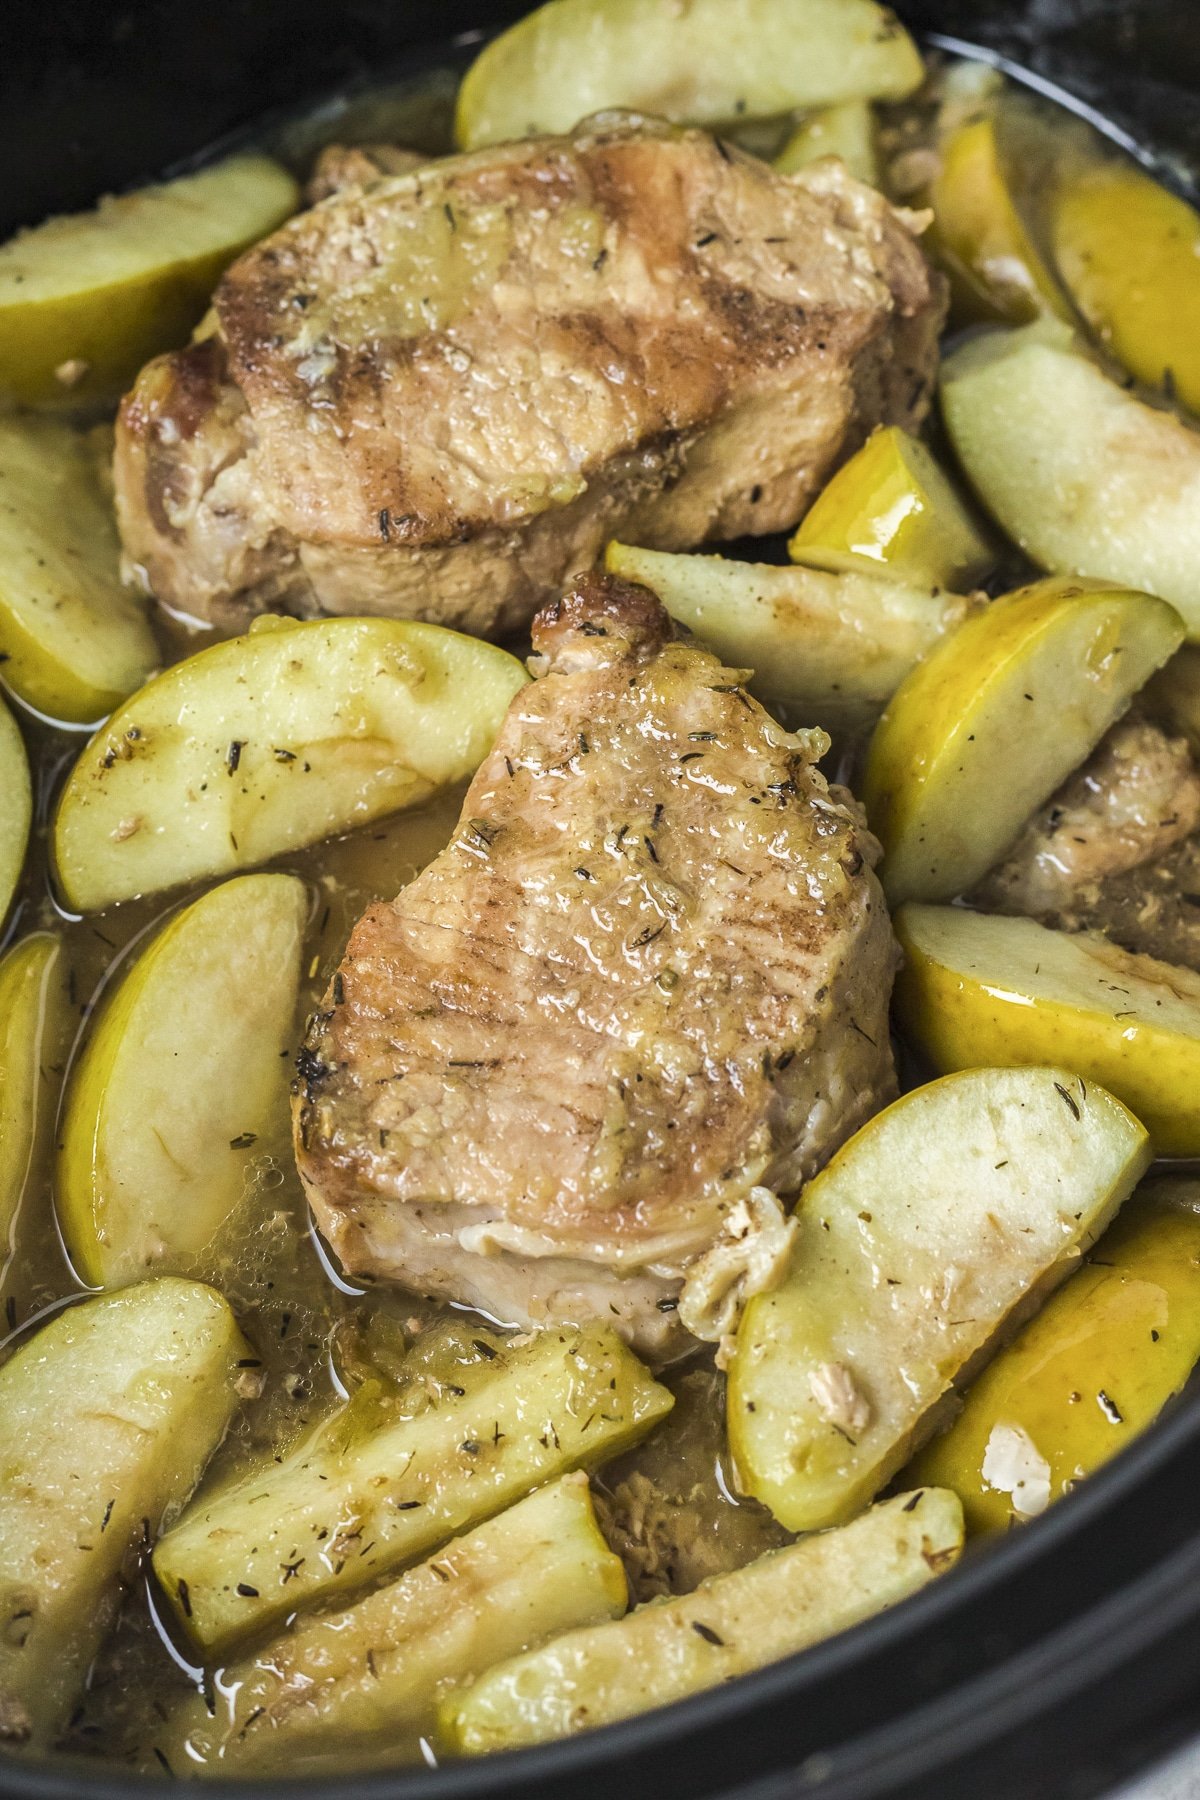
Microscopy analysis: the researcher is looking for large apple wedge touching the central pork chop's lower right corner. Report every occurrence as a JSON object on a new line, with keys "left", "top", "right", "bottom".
{"left": 727, "top": 1067, "right": 1150, "bottom": 1532}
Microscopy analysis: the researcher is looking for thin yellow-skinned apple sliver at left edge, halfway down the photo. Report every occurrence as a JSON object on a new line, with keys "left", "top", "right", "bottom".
{"left": 0, "top": 931, "right": 74, "bottom": 1269}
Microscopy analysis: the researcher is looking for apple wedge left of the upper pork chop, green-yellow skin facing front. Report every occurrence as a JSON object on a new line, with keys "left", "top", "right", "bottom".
{"left": 0, "top": 157, "right": 299, "bottom": 407}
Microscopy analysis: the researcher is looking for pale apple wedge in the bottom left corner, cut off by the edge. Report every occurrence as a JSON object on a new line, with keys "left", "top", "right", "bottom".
{"left": 0, "top": 1278, "right": 246, "bottom": 1744}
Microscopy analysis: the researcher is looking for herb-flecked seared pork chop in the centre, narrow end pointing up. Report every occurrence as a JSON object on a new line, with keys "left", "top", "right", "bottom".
{"left": 295, "top": 576, "right": 894, "bottom": 1355}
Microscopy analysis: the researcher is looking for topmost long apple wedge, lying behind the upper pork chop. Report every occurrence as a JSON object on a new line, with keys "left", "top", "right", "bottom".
{"left": 455, "top": 0, "right": 923, "bottom": 149}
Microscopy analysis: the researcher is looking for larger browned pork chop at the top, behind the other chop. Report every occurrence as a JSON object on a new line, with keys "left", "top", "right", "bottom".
{"left": 115, "top": 115, "right": 943, "bottom": 635}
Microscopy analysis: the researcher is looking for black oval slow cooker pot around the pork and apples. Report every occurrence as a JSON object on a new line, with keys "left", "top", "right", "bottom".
{"left": 0, "top": 0, "right": 1200, "bottom": 1800}
